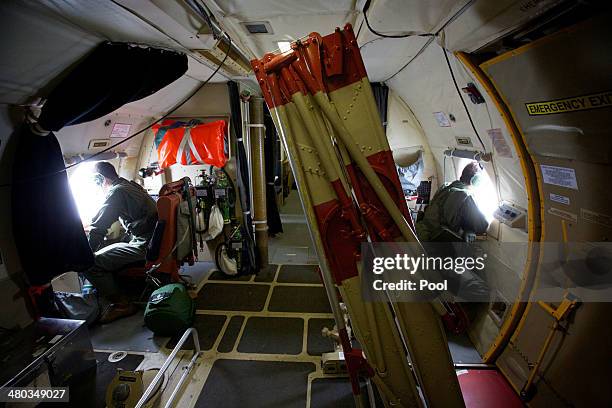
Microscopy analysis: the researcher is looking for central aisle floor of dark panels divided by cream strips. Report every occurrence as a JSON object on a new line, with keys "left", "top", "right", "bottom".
{"left": 179, "top": 265, "right": 353, "bottom": 407}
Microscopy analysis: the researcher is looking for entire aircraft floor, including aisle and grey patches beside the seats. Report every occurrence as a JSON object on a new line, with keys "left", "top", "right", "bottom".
{"left": 85, "top": 194, "right": 480, "bottom": 408}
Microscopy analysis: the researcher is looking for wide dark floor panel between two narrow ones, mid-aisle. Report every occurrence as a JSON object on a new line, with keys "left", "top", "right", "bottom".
{"left": 238, "top": 317, "right": 304, "bottom": 354}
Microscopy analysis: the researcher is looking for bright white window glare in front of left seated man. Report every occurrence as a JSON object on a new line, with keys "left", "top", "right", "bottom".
{"left": 69, "top": 162, "right": 105, "bottom": 224}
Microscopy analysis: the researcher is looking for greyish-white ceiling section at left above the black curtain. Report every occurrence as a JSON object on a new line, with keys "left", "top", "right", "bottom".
{"left": 0, "top": 0, "right": 228, "bottom": 108}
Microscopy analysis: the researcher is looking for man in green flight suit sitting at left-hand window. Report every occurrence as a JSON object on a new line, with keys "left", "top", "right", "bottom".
{"left": 83, "top": 162, "right": 157, "bottom": 323}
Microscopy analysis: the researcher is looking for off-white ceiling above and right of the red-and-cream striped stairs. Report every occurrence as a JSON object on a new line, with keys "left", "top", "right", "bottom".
{"left": 204, "top": 0, "right": 563, "bottom": 82}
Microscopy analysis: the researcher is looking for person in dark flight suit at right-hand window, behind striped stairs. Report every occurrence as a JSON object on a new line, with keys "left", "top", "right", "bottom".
{"left": 415, "top": 162, "right": 489, "bottom": 301}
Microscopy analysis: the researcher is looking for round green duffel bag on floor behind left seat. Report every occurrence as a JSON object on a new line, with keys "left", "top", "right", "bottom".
{"left": 144, "top": 283, "right": 195, "bottom": 336}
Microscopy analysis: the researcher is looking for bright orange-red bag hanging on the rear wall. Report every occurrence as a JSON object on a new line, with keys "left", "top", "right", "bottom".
{"left": 153, "top": 120, "right": 227, "bottom": 169}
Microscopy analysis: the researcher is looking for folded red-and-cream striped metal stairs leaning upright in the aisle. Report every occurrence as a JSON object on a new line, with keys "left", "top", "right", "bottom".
{"left": 251, "top": 24, "right": 464, "bottom": 407}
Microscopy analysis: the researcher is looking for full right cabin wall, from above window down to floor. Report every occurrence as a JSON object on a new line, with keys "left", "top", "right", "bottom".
{"left": 388, "top": 42, "right": 528, "bottom": 355}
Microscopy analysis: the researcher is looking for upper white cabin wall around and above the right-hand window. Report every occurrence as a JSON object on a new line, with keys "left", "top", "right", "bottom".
{"left": 388, "top": 43, "right": 527, "bottom": 217}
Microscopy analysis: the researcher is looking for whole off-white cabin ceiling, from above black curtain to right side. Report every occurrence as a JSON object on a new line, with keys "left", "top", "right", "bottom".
{"left": 0, "top": 0, "right": 561, "bottom": 108}
